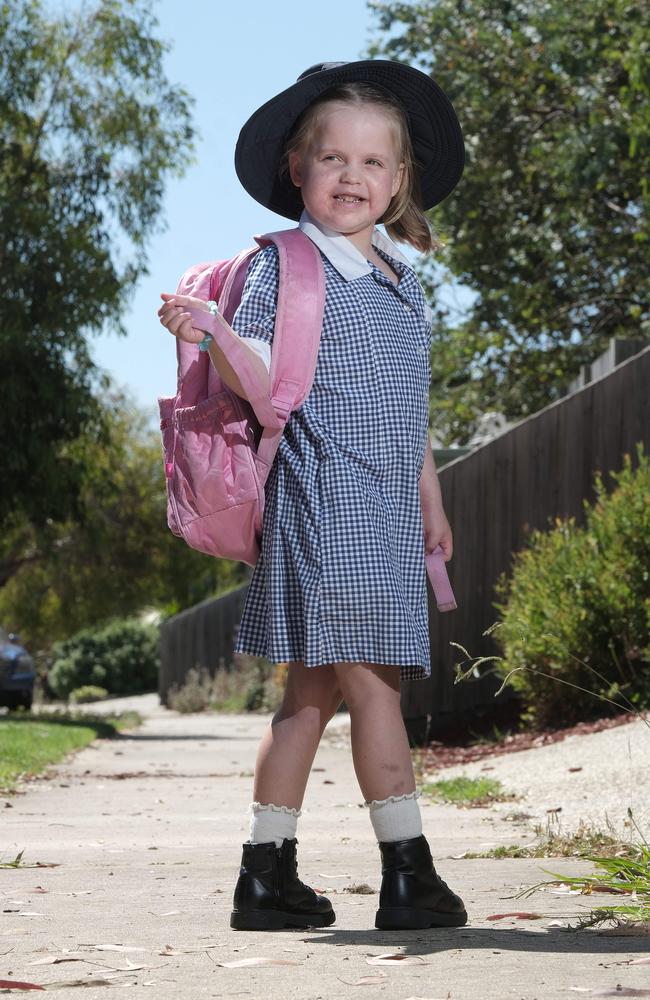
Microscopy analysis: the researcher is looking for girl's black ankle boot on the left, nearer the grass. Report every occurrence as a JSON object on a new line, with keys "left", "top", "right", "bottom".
{"left": 230, "top": 839, "right": 336, "bottom": 931}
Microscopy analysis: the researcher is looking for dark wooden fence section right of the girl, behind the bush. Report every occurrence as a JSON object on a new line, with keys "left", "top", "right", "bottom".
{"left": 402, "top": 347, "right": 650, "bottom": 742}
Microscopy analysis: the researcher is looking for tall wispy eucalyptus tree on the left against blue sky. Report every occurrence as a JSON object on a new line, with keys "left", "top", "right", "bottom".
{"left": 0, "top": 0, "right": 193, "bottom": 526}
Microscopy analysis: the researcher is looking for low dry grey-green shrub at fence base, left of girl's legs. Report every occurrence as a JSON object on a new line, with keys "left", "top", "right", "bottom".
{"left": 168, "top": 656, "right": 286, "bottom": 712}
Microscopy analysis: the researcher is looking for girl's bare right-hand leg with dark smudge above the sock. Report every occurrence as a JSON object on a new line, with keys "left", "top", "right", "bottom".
{"left": 334, "top": 663, "right": 415, "bottom": 802}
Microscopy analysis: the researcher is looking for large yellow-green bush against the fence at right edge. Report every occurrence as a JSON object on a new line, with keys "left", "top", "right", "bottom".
{"left": 495, "top": 446, "right": 650, "bottom": 726}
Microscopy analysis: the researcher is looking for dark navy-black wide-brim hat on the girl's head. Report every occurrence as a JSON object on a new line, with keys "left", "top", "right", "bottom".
{"left": 235, "top": 59, "right": 465, "bottom": 219}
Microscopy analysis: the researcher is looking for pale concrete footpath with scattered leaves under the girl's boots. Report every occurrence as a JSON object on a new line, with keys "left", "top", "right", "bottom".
{"left": 0, "top": 696, "right": 650, "bottom": 1000}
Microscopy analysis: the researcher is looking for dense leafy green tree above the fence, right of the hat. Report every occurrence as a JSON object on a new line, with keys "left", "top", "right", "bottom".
{"left": 370, "top": 0, "right": 650, "bottom": 443}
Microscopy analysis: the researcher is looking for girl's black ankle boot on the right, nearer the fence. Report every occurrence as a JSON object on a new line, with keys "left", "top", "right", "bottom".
{"left": 375, "top": 836, "right": 467, "bottom": 930}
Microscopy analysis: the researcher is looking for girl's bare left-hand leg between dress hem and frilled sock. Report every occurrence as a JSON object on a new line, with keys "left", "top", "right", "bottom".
{"left": 253, "top": 661, "right": 342, "bottom": 809}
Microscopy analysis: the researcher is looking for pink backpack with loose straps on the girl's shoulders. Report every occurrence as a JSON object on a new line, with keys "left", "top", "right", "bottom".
{"left": 158, "top": 229, "right": 456, "bottom": 611}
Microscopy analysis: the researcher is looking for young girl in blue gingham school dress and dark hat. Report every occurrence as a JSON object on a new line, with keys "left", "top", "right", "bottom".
{"left": 159, "top": 60, "right": 467, "bottom": 930}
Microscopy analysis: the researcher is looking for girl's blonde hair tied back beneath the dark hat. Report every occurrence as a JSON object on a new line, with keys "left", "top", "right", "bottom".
{"left": 278, "top": 83, "right": 440, "bottom": 253}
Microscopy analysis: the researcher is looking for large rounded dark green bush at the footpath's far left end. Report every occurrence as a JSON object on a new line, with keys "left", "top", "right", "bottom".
{"left": 48, "top": 618, "right": 160, "bottom": 698}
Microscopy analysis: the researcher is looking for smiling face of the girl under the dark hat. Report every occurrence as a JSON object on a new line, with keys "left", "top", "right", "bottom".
{"left": 289, "top": 102, "right": 404, "bottom": 256}
